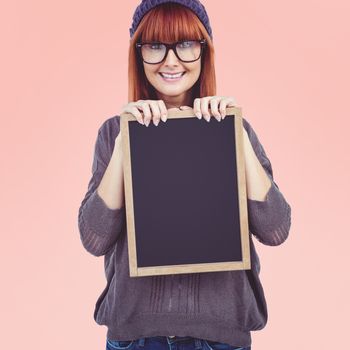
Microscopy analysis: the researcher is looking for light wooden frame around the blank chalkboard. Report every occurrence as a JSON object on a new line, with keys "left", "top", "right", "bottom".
{"left": 120, "top": 107, "right": 251, "bottom": 277}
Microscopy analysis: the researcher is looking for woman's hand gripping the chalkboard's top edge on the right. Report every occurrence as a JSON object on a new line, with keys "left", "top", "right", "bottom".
{"left": 180, "top": 96, "right": 236, "bottom": 122}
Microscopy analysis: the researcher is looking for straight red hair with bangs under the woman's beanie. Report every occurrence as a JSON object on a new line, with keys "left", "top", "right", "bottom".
{"left": 128, "top": 3, "right": 216, "bottom": 105}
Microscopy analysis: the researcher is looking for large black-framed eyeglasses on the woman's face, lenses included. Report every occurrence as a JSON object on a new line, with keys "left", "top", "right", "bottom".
{"left": 136, "top": 39, "right": 206, "bottom": 64}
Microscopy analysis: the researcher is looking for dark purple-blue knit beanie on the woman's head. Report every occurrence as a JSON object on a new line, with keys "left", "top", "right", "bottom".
{"left": 129, "top": 0, "right": 213, "bottom": 39}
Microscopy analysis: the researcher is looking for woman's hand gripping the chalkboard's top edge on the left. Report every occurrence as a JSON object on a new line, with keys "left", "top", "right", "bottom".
{"left": 121, "top": 100, "right": 168, "bottom": 126}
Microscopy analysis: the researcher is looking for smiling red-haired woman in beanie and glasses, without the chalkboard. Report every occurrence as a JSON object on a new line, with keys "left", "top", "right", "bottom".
{"left": 79, "top": 0, "right": 291, "bottom": 350}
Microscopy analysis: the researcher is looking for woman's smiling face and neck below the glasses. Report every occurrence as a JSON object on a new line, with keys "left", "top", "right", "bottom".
{"left": 143, "top": 40, "right": 201, "bottom": 108}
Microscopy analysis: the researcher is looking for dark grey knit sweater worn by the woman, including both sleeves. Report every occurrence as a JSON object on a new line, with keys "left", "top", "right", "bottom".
{"left": 78, "top": 116, "right": 291, "bottom": 346}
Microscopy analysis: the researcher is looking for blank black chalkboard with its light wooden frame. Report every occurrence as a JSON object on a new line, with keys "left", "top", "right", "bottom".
{"left": 121, "top": 107, "right": 250, "bottom": 276}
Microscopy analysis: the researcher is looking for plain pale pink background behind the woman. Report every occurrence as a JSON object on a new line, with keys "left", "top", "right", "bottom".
{"left": 0, "top": 0, "right": 350, "bottom": 350}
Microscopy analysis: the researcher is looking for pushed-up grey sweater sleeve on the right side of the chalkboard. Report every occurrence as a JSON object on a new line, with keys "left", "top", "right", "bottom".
{"left": 243, "top": 118, "right": 291, "bottom": 246}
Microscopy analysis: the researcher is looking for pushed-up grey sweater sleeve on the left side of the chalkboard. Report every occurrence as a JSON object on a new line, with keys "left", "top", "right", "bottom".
{"left": 78, "top": 118, "right": 125, "bottom": 256}
